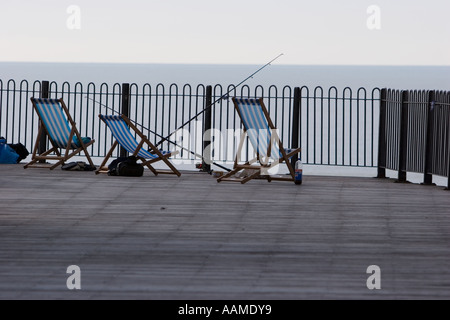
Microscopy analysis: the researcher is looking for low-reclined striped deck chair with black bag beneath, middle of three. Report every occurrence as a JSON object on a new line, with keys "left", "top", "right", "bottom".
{"left": 95, "top": 114, "right": 181, "bottom": 176}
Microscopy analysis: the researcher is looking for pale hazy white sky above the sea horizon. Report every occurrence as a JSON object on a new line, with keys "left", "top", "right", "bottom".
{"left": 0, "top": 0, "right": 450, "bottom": 66}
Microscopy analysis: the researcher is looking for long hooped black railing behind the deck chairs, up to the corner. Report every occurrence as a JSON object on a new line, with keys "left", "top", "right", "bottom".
{"left": 0, "top": 80, "right": 380, "bottom": 167}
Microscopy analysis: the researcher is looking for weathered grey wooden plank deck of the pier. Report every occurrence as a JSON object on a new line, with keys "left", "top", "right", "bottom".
{"left": 0, "top": 165, "right": 450, "bottom": 300}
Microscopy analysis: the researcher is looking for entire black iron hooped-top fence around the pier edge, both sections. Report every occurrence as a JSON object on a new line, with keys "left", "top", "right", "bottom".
{"left": 0, "top": 80, "right": 450, "bottom": 188}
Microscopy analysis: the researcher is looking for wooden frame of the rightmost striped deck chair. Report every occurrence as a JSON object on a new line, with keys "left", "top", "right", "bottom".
{"left": 217, "top": 98, "right": 301, "bottom": 184}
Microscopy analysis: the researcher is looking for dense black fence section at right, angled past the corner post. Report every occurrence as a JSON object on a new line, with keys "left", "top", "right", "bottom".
{"left": 378, "top": 89, "right": 450, "bottom": 188}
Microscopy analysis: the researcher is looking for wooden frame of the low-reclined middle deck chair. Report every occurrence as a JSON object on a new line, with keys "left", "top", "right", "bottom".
{"left": 95, "top": 114, "right": 181, "bottom": 176}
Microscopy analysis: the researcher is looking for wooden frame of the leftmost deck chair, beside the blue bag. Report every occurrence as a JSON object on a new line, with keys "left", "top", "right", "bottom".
{"left": 24, "top": 98, "right": 95, "bottom": 170}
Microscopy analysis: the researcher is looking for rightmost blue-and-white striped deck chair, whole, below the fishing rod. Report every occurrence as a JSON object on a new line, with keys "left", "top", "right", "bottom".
{"left": 217, "top": 98, "right": 301, "bottom": 184}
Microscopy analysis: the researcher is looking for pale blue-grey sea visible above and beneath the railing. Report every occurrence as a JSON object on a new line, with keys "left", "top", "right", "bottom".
{"left": 0, "top": 62, "right": 450, "bottom": 185}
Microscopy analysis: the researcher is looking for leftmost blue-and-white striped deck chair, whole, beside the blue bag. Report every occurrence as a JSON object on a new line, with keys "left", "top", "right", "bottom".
{"left": 24, "top": 98, "right": 95, "bottom": 170}
